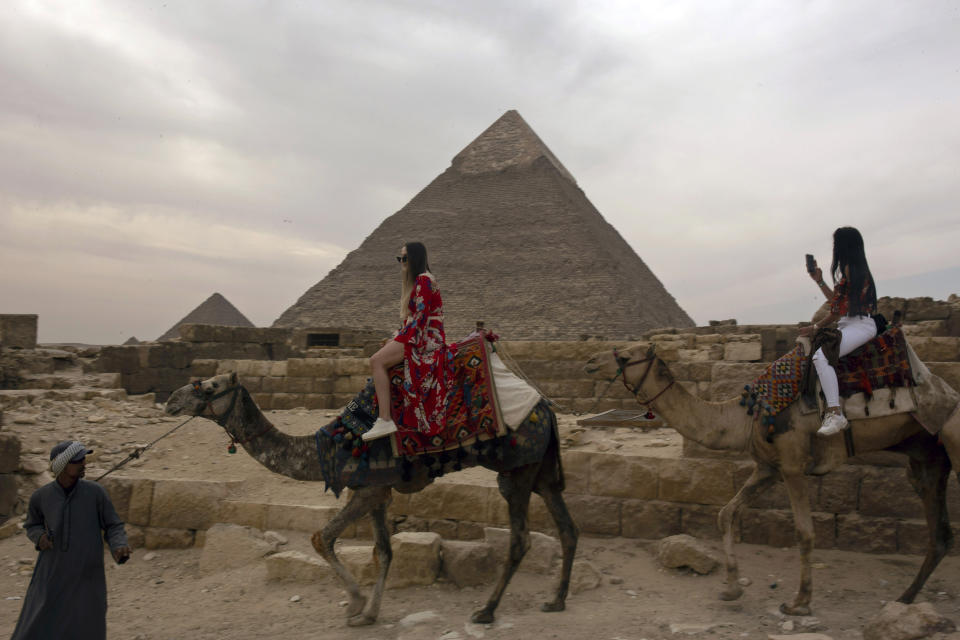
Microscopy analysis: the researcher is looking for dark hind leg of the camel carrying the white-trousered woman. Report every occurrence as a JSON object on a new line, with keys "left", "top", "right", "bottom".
{"left": 897, "top": 456, "right": 953, "bottom": 604}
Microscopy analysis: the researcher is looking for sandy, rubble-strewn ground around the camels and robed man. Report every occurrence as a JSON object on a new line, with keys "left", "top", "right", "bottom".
{"left": 0, "top": 400, "right": 960, "bottom": 640}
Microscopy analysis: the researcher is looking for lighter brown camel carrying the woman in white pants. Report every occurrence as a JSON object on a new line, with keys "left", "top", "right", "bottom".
{"left": 586, "top": 343, "right": 960, "bottom": 615}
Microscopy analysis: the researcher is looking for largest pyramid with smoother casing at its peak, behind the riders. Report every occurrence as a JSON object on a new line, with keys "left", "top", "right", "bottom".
{"left": 274, "top": 111, "right": 694, "bottom": 342}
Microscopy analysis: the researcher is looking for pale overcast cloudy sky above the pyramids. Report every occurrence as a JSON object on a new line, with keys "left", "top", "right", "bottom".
{"left": 0, "top": 0, "right": 960, "bottom": 344}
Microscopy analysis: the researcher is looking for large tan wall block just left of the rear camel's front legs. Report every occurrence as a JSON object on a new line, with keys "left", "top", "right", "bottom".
{"left": 658, "top": 459, "right": 735, "bottom": 505}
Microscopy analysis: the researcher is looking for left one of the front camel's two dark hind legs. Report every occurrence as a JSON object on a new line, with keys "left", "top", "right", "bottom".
{"left": 470, "top": 463, "right": 540, "bottom": 623}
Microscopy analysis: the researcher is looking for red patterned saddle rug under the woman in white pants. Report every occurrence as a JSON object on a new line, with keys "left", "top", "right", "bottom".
{"left": 740, "top": 326, "right": 915, "bottom": 440}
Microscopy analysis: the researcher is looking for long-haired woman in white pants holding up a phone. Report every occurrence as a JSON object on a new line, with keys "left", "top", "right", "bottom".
{"left": 800, "top": 227, "right": 877, "bottom": 436}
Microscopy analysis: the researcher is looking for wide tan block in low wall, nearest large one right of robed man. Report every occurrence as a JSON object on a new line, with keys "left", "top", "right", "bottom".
{"left": 150, "top": 480, "right": 227, "bottom": 529}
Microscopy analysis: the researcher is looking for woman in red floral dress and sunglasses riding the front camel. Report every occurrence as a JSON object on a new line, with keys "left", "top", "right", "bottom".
{"left": 363, "top": 242, "right": 449, "bottom": 440}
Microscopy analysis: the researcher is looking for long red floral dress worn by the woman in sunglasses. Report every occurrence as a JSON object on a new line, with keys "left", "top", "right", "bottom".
{"left": 393, "top": 274, "right": 450, "bottom": 435}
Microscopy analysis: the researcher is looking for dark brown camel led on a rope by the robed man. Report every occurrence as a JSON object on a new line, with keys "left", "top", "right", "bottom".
{"left": 166, "top": 373, "right": 578, "bottom": 626}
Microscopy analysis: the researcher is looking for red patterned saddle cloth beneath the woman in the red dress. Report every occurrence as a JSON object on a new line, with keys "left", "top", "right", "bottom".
{"left": 389, "top": 335, "right": 507, "bottom": 456}
